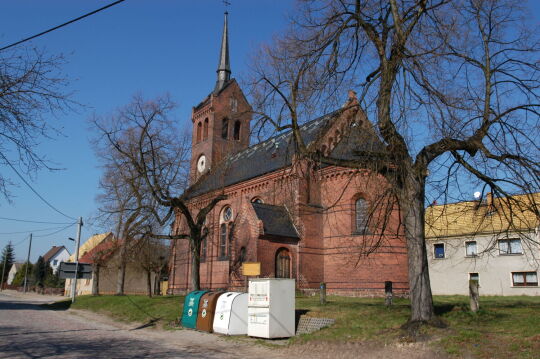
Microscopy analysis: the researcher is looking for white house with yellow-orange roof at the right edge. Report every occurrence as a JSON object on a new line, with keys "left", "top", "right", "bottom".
{"left": 426, "top": 193, "right": 540, "bottom": 295}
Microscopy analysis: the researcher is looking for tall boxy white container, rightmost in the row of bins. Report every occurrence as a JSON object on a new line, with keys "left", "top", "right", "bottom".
{"left": 248, "top": 278, "right": 295, "bottom": 338}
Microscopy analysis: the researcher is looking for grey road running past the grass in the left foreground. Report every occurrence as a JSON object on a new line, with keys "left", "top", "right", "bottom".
{"left": 0, "top": 292, "right": 286, "bottom": 359}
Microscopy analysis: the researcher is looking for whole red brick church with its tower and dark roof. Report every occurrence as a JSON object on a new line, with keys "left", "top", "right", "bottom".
{"left": 169, "top": 14, "right": 409, "bottom": 296}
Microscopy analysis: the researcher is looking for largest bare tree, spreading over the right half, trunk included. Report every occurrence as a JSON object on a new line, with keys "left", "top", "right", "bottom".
{"left": 252, "top": 0, "right": 540, "bottom": 325}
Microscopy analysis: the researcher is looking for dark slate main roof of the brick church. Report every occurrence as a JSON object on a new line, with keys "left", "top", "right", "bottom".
{"left": 187, "top": 110, "right": 382, "bottom": 198}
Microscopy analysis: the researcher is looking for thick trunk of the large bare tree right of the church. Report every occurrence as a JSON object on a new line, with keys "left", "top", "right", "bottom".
{"left": 400, "top": 178, "right": 435, "bottom": 323}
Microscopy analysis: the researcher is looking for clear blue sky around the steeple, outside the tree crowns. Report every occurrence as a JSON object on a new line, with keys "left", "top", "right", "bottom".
{"left": 0, "top": 0, "right": 293, "bottom": 261}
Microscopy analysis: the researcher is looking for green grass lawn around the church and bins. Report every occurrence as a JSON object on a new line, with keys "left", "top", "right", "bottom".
{"left": 44, "top": 295, "right": 540, "bottom": 358}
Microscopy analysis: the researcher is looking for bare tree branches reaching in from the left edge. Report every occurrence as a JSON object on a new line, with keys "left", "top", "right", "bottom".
{"left": 0, "top": 47, "right": 73, "bottom": 200}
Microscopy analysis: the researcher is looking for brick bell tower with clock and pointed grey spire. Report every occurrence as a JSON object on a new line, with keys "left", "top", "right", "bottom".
{"left": 190, "top": 12, "right": 252, "bottom": 183}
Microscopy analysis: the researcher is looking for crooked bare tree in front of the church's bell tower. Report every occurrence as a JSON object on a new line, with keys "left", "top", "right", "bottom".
{"left": 92, "top": 96, "right": 226, "bottom": 290}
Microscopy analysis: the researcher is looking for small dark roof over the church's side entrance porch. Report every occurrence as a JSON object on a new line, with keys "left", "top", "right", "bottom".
{"left": 252, "top": 203, "right": 299, "bottom": 238}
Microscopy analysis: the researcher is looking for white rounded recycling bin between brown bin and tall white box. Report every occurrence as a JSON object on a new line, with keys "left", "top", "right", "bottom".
{"left": 214, "top": 292, "right": 248, "bottom": 335}
